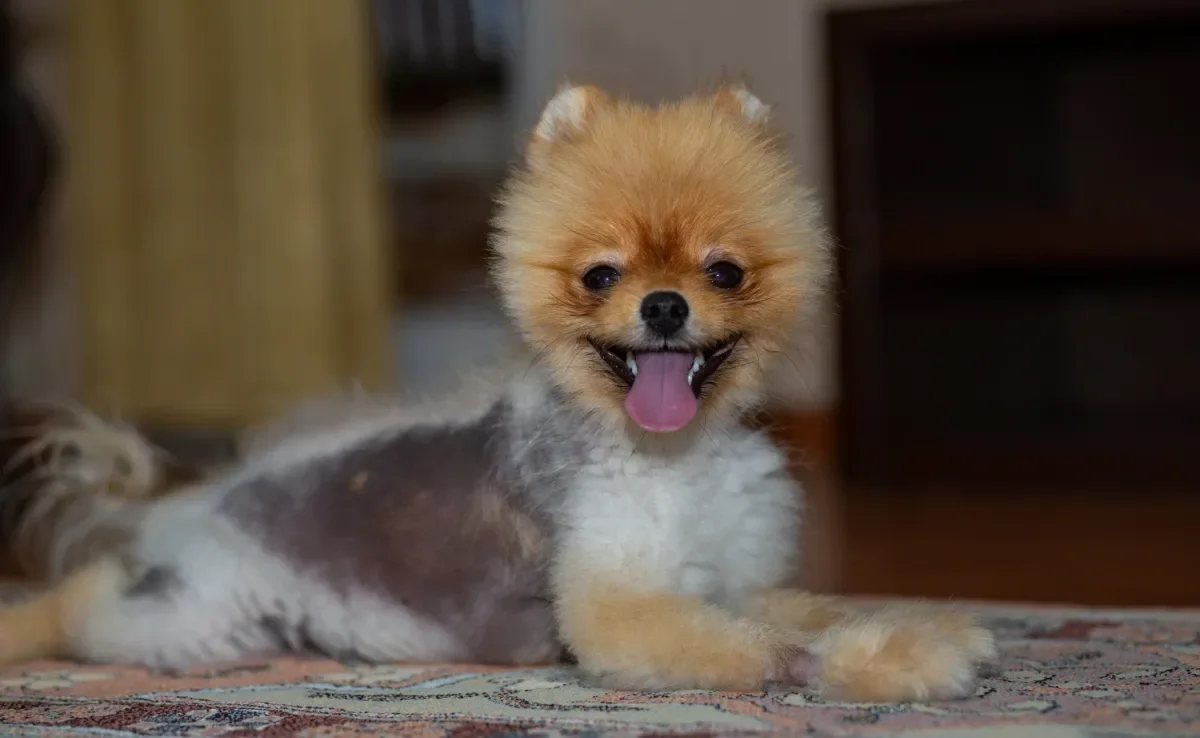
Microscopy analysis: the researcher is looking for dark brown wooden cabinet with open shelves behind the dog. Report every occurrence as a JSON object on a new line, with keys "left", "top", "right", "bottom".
{"left": 828, "top": 0, "right": 1200, "bottom": 487}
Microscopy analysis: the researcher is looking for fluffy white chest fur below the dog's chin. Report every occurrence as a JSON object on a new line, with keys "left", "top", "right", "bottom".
{"left": 564, "top": 432, "right": 799, "bottom": 606}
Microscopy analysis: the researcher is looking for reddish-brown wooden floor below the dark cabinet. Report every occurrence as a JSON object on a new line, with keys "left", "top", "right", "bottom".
{"left": 836, "top": 488, "right": 1200, "bottom": 606}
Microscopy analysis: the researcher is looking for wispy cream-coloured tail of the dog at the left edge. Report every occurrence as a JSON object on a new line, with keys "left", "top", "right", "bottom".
{"left": 0, "top": 403, "right": 204, "bottom": 582}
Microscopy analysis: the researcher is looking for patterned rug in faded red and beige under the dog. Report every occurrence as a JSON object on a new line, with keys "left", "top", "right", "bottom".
{"left": 0, "top": 607, "right": 1200, "bottom": 738}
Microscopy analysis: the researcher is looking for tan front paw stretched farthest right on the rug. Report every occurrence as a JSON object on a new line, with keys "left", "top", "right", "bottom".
{"left": 812, "top": 608, "right": 996, "bottom": 702}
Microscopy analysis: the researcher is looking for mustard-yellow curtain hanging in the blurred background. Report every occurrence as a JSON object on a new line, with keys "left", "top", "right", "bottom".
{"left": 67, "top": 0, "right": 391, "bottom": 428}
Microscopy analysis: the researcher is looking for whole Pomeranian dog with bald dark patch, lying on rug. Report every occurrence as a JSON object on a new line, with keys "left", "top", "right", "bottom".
{"left": 0, "top": 86, "right": 995, "bottom": 701}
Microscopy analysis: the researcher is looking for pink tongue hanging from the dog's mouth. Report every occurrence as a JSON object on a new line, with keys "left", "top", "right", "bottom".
{"left": 625, "top": 352, "right": 696, "bottom": 433}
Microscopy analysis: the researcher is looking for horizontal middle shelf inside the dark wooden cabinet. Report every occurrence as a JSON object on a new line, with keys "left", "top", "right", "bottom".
{"left": 878, "top": 209, "right": 1200, "bottom": 270}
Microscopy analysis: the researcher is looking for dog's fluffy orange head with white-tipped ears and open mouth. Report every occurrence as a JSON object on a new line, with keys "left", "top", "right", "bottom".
{"left": 494, "top": 88, "right": 827, "bottom": 432}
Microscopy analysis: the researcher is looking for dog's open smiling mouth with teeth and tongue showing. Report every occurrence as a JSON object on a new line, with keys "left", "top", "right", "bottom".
{"left": 592, "top": 336, "right": 740, "bottom": 433}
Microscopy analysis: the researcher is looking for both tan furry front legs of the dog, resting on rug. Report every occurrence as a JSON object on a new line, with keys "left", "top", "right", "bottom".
{"left": 559, "top": 578, "right": 996, "bottom": 702}
